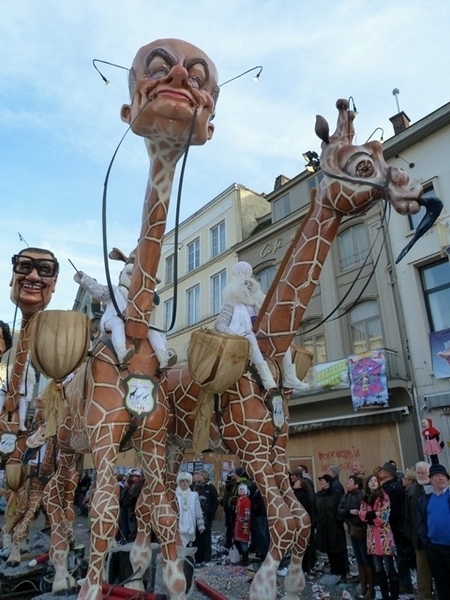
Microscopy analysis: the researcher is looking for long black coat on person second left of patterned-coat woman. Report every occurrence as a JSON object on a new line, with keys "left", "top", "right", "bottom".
{"left": 316, "top": 488, "right": 347, "bottom": 552}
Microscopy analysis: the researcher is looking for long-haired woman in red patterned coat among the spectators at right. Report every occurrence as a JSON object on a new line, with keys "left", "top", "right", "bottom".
{"left": 359, "top": 475, "right": 399, "bottom": 600}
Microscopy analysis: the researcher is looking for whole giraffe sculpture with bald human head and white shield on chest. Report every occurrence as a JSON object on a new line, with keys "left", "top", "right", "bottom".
{"left": 45, "top": 39, "right": 218, "bottom": 600}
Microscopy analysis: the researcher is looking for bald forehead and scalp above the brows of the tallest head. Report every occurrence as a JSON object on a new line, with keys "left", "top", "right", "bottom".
{"left": 133, "top": 38, "right": 218, "bottom": 87}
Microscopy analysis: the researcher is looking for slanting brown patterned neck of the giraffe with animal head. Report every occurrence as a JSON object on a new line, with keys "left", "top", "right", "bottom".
{"left": 255, "top": 191, "right": 342, "bottom": 360}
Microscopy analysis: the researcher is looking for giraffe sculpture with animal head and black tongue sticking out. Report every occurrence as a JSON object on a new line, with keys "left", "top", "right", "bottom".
{"left": 168, "top": 100, "right": 440, "bottom": 600}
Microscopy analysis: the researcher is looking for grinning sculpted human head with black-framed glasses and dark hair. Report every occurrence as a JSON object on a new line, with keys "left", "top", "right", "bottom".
{"left": 9, "top": 248, "right": 59, "bottom": 314}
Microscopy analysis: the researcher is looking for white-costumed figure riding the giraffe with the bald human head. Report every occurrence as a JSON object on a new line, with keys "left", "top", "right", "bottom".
{"left": 73, "top": 263, "right": 177, "bottom": 369}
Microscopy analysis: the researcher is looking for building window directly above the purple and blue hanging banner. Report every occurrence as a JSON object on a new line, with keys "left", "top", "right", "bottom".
{"left": 348, "top": 301, "right": 383, "bottom": 354}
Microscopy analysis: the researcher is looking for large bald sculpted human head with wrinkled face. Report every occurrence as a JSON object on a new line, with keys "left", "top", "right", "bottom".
{"left": 121, "top": 39, "right": 219, "bottom": 145}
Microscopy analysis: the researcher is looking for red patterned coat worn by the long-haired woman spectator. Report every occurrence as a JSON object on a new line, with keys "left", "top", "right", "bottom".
{"left": 359, "top": 494, "right": 397, "bottom": 556}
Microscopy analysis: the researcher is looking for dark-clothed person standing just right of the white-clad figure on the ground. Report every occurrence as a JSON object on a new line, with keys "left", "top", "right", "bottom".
{"left": 192, "top": 471, "right": 219, "bottom": 567}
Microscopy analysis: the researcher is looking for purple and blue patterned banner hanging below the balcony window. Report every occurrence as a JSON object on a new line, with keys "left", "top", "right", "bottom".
{"left": 348, "top": 350, "right": 389, "bottom": 411}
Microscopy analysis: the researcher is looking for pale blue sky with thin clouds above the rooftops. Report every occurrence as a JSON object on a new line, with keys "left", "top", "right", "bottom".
{"left": 0, "top": 0, "right": 450, "bottom": 323}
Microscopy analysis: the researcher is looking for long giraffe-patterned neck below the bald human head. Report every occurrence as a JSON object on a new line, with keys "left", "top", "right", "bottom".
{"left": 125, "top": 152, "right": 179, "bottom": 340}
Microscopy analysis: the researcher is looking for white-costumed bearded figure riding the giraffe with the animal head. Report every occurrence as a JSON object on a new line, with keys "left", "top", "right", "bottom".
{"left": 215, "top": 261, "right": 310, "bottom": 391}
